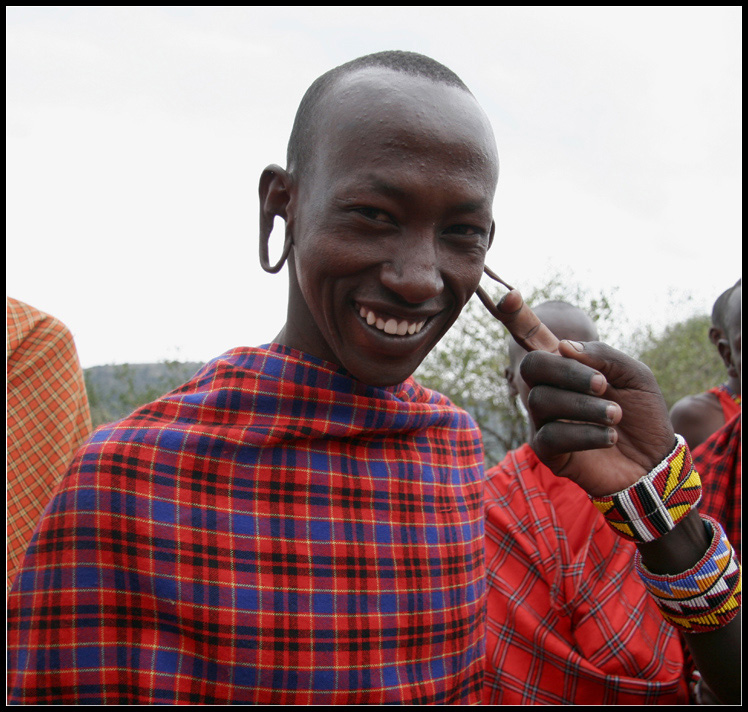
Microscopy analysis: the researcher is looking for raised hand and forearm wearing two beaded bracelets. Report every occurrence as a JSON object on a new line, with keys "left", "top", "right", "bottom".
{"left": 521, "top": 341, "right": 741, "bottom": 703}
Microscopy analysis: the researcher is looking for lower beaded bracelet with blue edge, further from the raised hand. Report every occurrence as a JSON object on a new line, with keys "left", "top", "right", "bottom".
{"left": 635, "top": 514, "right": 742, "bottom": 633}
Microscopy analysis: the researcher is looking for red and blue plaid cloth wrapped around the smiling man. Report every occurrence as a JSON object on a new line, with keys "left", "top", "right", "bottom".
{"left": 8, "top": 345, "right": 485, "bottom": 705}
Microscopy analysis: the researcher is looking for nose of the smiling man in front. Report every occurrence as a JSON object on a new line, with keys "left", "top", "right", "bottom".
{"left": 380, "top": 235, "right": 444, "bottom": 304}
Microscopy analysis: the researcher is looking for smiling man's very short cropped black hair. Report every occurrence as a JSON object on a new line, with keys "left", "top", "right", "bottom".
{"left": 286, "top": 50, "right": 471, "bottom": 175}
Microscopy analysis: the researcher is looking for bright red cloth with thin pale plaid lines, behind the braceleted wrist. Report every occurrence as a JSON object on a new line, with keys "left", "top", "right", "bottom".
{"left": 483, "top": 444, "right": 688, "bottom": 705}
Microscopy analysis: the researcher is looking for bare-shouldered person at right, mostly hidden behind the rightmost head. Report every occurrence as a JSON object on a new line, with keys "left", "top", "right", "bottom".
{"left": 670, "top": 280, "right": 741, "bottom": 450}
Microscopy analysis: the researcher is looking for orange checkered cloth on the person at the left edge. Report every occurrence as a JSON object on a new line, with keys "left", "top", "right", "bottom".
{"left": 6, "top": 297, "right": 91, "bottom": 589}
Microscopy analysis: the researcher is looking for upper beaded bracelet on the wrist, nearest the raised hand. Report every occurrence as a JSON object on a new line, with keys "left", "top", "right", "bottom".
{"left": 591, "top": 435, "right": 701, "bottom": 542}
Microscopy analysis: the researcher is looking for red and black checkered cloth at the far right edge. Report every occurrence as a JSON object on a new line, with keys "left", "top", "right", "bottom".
{"left": 692, "top": 413, "right": 743, "bottom": 562}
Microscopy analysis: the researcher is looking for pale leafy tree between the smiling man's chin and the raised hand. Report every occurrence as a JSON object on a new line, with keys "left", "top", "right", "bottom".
{"left": 415, "top": 274, "right": 618, "bottom": 467}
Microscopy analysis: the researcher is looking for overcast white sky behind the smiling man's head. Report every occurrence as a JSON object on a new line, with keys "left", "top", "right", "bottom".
{"left": 6, "top": 6, "right": 742, "bottom": 367}
